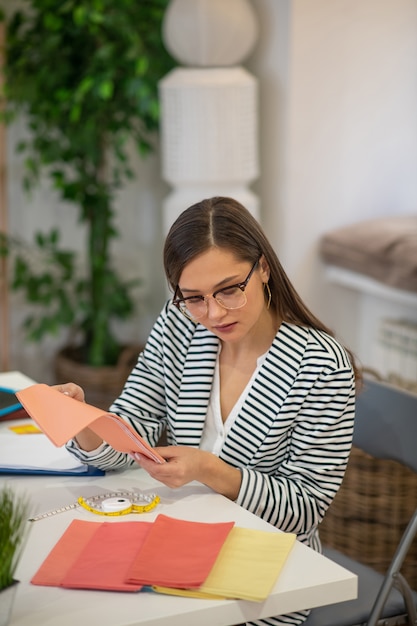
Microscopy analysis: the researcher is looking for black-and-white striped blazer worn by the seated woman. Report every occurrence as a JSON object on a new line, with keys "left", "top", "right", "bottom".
{"left": 68, "top": 303, "right": 355, "bottom": 549}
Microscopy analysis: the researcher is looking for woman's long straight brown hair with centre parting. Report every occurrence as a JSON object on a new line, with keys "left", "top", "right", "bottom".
{"left": 164, "top": 196, "right": 360, "bottom": 379}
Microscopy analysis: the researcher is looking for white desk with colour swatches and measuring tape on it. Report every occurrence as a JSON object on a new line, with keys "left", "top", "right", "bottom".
{"left": 0, "top": 370, "right": 357, "bottom": 626}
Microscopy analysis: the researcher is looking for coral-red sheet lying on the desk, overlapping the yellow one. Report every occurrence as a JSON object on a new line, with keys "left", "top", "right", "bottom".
{"left": 127, "top": 515, "right": 234, "bottom": 589}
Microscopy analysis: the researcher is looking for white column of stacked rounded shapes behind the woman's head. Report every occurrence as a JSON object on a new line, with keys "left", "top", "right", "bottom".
{"left": 159, "top": 0, "right": 259, "bottom": 232}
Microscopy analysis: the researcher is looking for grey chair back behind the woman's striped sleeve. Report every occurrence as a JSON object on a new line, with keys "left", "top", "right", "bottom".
{"left": 353, "top": 378, "right": 417, "bottom": 473}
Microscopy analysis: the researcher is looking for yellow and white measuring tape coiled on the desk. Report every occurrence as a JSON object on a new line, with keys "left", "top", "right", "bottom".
{"left": 29, "top": 491, "right": 160, "bottom": 522}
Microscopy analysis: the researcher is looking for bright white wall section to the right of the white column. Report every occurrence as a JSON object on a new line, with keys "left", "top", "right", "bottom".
{"left": 250, "top": 0, "right": 417, "bottom": 361}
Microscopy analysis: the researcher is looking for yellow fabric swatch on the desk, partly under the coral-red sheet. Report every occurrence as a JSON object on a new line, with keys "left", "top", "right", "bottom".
{"left": 200, "top": 527, "right": 295, "bottom": 602}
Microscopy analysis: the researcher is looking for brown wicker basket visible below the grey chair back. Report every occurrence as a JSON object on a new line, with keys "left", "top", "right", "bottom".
{"left": 320, "top": 447, "right": 417, "bottom": 589}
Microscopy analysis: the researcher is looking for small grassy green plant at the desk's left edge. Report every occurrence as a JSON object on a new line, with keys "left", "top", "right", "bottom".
{"left": 0, "top": 485, "right": 29, "bottom": 591}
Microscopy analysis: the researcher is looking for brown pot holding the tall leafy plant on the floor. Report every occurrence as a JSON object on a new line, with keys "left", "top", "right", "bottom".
{"left": 54, "top": 345, "right": 142, "bottom": 409}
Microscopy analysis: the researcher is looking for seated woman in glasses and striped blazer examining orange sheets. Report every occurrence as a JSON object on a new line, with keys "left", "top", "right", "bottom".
{"left": 61, "top": 197, "right": 356, "bottom": 625}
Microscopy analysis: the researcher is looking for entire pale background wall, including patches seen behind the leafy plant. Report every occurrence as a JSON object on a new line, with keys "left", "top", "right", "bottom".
{"left": 3, "top": 0, "right": 417, "bottom": 380}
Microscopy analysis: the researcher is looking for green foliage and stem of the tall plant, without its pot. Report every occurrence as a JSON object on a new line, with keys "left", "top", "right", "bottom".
{"left": 0, "top": 0, "right": 175, "bottom": 394}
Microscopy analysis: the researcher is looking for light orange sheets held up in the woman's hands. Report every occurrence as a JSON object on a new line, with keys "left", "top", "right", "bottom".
{"left": 16, "top": 384, "right": 165, "bottom": 463}
